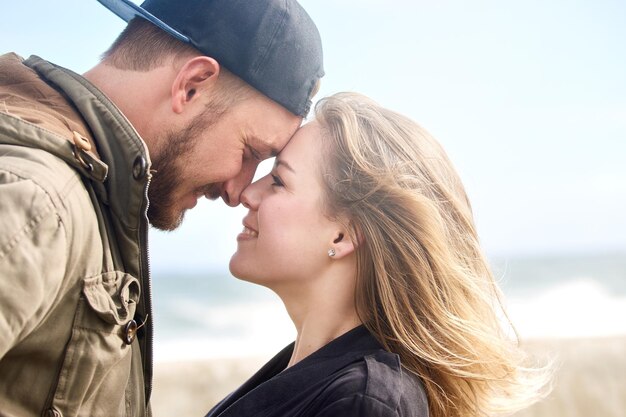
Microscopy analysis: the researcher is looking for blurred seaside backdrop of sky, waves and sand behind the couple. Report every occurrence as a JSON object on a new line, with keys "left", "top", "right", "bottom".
{"left": 0, "top": 0, "right": 626, "bottom": 417}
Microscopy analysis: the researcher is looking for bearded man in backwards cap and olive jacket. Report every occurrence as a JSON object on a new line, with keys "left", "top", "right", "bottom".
{"left": 0, "top": 0, "right": 323, "bottom": 417}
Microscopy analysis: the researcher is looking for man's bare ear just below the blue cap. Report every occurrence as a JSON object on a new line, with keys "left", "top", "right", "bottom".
{"left": 172, "top": 56, "right": 220, "bottom": 114}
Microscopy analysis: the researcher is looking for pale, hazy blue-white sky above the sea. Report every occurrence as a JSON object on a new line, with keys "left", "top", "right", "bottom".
{"left": 0, "top": 0, "right": 626, "bottom": 272}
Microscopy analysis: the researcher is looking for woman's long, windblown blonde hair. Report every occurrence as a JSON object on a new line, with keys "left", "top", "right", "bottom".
{"left": 315, "top": 93, "right": 547, "bottom": 417}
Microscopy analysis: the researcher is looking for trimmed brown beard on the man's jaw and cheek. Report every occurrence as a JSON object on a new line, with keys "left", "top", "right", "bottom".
{"left": 148, "top": 108, "right": 222, "bottom": 231}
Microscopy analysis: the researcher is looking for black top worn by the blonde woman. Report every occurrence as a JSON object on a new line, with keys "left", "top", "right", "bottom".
{"left": 206, "top": 326, "right": 428, "bottom": 417}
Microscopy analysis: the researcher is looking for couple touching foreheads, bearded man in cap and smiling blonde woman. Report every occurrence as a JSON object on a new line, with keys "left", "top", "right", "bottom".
{"left": 0, "top": 0, "right": 541, "bottom": 417}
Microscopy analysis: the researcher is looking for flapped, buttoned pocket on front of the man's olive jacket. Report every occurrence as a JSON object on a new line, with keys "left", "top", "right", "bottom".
{"left": 52, "top": 271, "right": 142, "bottom": 417}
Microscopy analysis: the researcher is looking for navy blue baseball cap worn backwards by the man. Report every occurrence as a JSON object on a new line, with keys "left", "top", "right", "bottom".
{"left": 98, "top": 0, "right": 324, "bottom": 117}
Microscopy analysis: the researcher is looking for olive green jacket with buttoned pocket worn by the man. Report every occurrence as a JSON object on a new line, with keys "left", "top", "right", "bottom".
{"left": 0, "top": 54, "right": 152, "bottom": 417}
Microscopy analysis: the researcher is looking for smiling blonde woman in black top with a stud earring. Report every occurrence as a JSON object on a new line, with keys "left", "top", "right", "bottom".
{"left": 208, "top": 93, "right": 545, "bottom": 417}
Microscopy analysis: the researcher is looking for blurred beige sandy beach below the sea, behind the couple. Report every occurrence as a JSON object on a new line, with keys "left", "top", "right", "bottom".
{"left": 152, "top": 336, "right": 626, "bottom": 417}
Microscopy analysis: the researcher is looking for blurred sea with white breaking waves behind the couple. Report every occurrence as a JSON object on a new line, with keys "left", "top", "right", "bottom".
{"left": 152, "top": 252, "right": 626, "bottom": 361}
